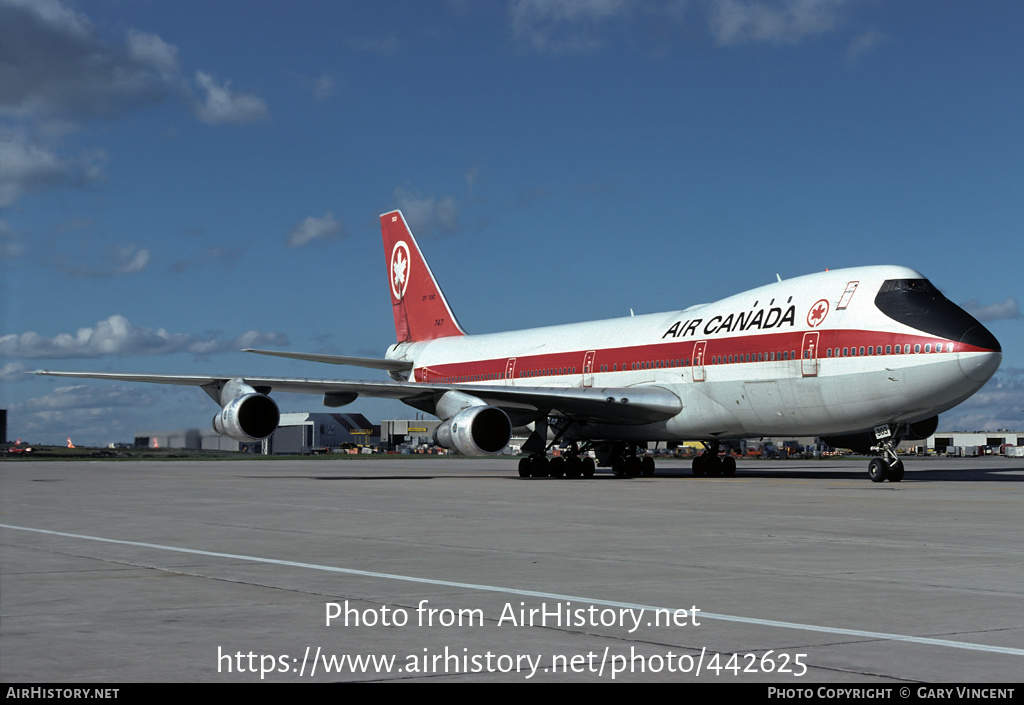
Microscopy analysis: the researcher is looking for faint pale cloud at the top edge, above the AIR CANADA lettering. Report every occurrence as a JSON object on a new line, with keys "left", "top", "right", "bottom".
{"left": 708, "top": 0, "right": 849, "bottom": 46}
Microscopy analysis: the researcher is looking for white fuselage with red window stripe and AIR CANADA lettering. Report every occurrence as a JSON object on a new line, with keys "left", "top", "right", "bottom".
{"left": 388, "top": 266, "right": 1001, "bottom": 441}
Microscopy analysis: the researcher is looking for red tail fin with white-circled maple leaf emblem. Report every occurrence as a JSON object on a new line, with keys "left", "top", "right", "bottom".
{"left": 381, "top": 210, "right": 466, "bottom": 342}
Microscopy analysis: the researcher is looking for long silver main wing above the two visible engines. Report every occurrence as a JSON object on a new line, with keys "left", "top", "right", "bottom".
{"left": 34, "top": 370, "right": 683, "bottom": 424}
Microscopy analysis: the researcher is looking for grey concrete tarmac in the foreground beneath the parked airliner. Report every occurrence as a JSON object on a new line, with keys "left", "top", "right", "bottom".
{"left": 0, "top": 457, "right": 1024, "bottom": 693}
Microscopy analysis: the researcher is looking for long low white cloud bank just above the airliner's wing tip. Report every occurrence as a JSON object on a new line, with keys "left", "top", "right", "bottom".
{"left": 0, "top": 314, "right": 288, "bottom": 360}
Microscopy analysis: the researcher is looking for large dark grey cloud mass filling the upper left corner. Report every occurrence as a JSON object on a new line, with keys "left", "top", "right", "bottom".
{"left": 0, "top": 0, "right": 268, "bottom": 208}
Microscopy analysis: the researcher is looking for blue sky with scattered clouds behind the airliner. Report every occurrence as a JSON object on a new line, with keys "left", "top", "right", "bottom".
{"left": 0, "top": 0, "right": 1024, "bottom": 444}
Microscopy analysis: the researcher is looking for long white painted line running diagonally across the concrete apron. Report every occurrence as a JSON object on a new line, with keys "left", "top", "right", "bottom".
{"left": 0, "top": 524, "right": 1024, "bottom": 656}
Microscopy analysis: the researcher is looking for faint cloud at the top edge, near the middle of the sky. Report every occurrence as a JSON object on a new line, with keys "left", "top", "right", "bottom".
{"left": 509, "top": 0, "right": 632, "bottom": 52}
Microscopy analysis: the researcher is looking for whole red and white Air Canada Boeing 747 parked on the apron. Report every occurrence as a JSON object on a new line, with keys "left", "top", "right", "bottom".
{"left": 38, "top": 211, "right": 1001, "bottom": 482}
